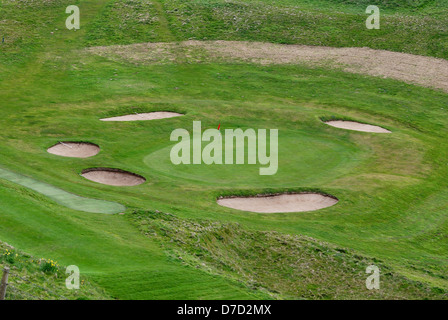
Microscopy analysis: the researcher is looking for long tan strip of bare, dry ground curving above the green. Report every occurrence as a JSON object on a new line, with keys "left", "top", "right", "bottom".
{"left": 87, "top": 40, "right": 448, "bottom": 92}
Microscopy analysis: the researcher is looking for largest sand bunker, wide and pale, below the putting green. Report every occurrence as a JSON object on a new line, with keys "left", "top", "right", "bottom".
{"left": 218, "top": 193, "right": 338, "bottom": 213}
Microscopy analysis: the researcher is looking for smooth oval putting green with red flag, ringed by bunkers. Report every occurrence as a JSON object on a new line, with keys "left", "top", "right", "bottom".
{"left": 144, "top": 130, "right": 363, "bottom": 187}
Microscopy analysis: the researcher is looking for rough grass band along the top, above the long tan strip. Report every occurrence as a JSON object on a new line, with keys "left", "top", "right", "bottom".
{"left": 80, "top": 0, "right": 448, "bottom": 58}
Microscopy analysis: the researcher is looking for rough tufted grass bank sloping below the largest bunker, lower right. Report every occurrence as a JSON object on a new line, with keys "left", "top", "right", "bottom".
{"left": 129, "top": 211, "right": 448, "bottom": 299}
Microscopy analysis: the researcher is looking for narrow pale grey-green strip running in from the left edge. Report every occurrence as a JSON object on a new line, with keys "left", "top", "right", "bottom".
{"left": 0, "top": 168, "right": 126, "bottom": 214}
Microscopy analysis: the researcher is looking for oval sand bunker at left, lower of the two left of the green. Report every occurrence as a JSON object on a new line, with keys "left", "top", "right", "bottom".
{"left": 81, "top": 168, "right": 146, "bottom": 186}
